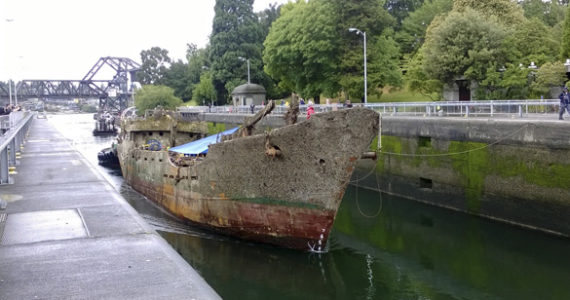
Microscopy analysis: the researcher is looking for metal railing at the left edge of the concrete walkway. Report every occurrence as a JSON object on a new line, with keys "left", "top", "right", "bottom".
{"left": 0, "top": 112, "right": 34, "bottom": 184}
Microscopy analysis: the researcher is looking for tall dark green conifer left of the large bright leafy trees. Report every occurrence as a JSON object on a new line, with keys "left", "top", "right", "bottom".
{"left": 209, "top": 0, "right": 263, "bottom": 103}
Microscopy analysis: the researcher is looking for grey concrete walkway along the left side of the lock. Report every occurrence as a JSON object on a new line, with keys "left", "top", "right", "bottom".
{"left": 0, "top": 119, "right": 220, "bottom": 299}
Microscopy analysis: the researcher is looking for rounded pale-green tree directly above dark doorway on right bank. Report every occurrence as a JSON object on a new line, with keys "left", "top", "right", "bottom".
{"left": 423, "top": 8, "right": 507, "bottom": 83}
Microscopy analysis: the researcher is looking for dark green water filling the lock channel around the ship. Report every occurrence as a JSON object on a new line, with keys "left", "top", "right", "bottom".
{"left": 51, "top": 116, "right": 570, "bottom": 299}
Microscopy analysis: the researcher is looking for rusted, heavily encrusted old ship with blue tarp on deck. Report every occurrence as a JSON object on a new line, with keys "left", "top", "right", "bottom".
{"left": 118, "top": 102, "right": 379, "bottom": 251}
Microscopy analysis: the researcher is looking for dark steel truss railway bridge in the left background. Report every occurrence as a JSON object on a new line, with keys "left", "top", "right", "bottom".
{"left": 0, "top": 56, "right": 140, "bottom": 111}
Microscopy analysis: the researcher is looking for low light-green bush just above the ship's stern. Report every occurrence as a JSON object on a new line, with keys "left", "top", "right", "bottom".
{"left": 135, "top": 85, "right": 182, "bottom": 114}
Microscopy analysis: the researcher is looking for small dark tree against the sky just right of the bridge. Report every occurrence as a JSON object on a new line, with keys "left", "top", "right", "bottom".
{"left": 137, "top": 47, "right": 170, "bottom": 84}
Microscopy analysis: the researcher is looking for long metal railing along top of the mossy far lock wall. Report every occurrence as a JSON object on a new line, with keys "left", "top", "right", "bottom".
{"left": 178, "top": 99, "right": 560, "bottom": 118}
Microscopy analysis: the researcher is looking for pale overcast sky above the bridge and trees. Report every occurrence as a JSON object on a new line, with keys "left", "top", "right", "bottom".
{"left": 0, "top": 0, "right": 287, "bottom": 81}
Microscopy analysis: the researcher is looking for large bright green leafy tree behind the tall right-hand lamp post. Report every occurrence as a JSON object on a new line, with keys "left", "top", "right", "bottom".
{"left": 263, "top": 0, "right": 400, "bottom": 103}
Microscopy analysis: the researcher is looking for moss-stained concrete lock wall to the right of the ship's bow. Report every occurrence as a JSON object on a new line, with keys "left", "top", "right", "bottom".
{"left": 353, "top": 117, "right": 570, "bottom": 237}
